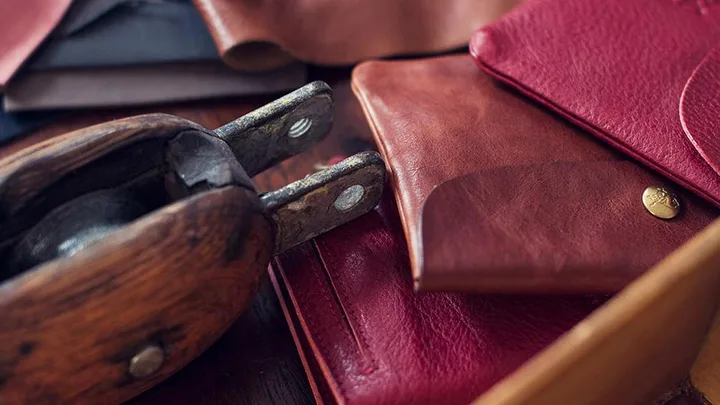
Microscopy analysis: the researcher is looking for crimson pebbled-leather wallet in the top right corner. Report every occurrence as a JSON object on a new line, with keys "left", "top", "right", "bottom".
{"left": 470, "top": 0, "right": 720, "bottom": 205}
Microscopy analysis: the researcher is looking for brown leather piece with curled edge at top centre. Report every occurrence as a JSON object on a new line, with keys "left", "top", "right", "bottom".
{"left": 188, "top": 0, "right": 519, "bottom": 70}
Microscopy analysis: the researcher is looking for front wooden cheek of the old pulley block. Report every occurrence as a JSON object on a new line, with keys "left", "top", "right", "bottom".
{"left": 0, "top": 187, "right": 273, "bottom": 405}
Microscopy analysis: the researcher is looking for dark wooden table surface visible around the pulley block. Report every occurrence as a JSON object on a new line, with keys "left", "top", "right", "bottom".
{"left": 0, "top": 68, "right": 375, "bottom": 405}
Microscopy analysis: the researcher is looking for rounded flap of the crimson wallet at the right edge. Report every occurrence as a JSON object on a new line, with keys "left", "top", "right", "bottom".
{"left": 680, "top": 44, "right": 720, "bottom": 178}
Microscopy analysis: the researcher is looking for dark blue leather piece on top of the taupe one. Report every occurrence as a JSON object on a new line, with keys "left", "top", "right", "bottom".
{"left": 24, "top": 0, "right": 220, "bottom": 71}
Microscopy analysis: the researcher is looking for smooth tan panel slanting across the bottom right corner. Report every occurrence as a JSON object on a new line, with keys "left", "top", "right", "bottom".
{"left": 475, "top": 220, "right": 720, "bottom": 405}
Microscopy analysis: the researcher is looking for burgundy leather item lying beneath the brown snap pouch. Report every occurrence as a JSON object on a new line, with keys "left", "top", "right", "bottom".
{"left": 271, "top": 193, "right": 603, "bottom": 405}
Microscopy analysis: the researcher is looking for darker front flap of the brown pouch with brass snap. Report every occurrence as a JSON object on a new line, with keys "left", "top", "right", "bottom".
{"left": 419, "top": 161, "right": 716, "bottom": 293}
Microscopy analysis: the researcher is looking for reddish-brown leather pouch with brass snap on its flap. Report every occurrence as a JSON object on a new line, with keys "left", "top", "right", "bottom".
{"left": 353, "top": 55, "right": 717, "bottom": 293}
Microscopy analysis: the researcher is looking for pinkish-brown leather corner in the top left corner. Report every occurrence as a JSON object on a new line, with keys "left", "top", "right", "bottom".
{"left": 0, "top": 0, "right": 72, "bottom": 91}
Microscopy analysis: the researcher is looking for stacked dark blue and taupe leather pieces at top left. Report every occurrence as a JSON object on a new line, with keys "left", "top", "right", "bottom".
{"left": 3, "top": 0, "right": 307, "bottom": 112}
